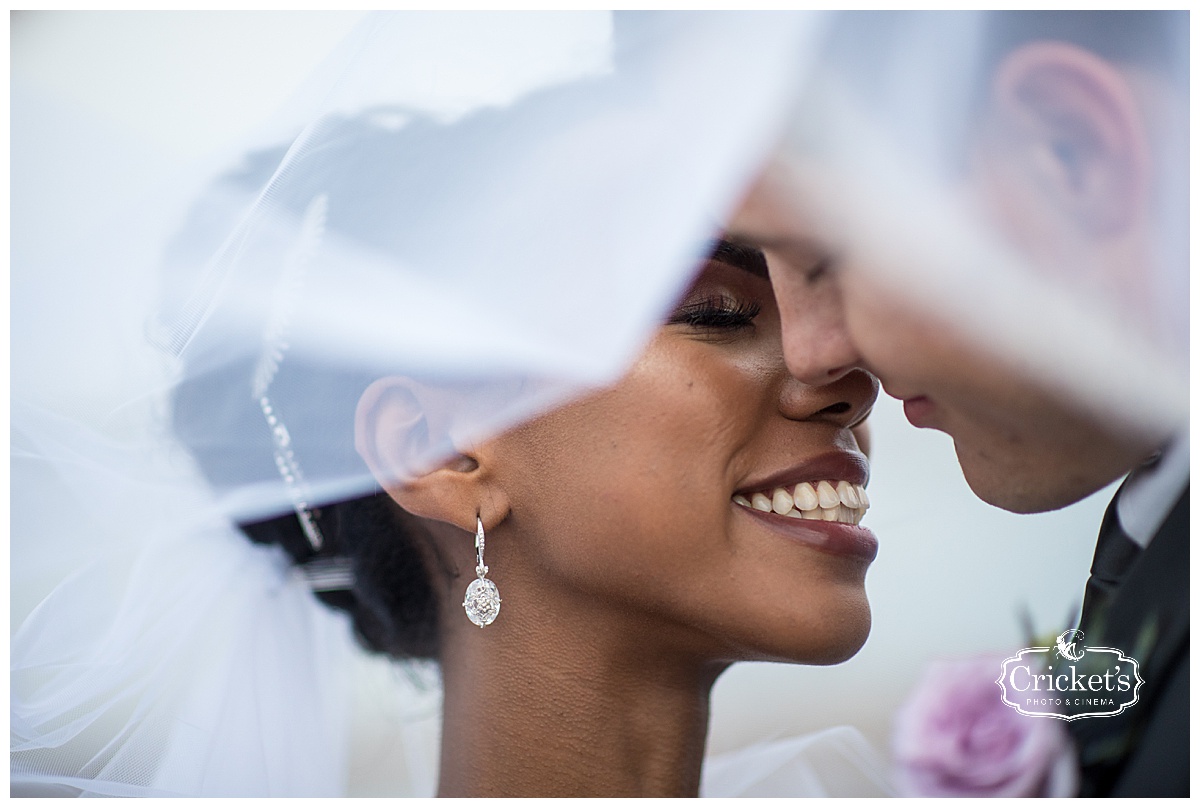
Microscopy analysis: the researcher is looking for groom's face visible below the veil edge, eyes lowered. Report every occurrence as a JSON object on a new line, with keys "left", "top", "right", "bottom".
{"left": 734, "top": 231, "right": 1150, "bottom": 513}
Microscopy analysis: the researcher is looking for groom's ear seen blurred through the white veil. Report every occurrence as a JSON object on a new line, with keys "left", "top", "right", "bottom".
{"left": 983, "top": 42, "right": 1151, "bottom": 238}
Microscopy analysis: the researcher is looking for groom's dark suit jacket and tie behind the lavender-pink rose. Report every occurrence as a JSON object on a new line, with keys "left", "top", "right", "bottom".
{"left": 1068, "top": 490, "right": 1190, "bottom": 797}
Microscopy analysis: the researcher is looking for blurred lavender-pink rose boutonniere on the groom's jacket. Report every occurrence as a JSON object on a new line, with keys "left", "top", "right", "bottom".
{"left": 893, "top": 656, "right": 1079, "bottom": 797}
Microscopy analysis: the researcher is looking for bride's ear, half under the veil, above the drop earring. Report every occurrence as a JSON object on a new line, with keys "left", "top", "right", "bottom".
{"left": 354, "top": 376, "right": 508, "bottom": 532}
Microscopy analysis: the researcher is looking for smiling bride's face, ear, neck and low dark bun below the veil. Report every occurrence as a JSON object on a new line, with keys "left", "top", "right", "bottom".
{"left": 211, "top": 244, "right": 876, "bottom": 796}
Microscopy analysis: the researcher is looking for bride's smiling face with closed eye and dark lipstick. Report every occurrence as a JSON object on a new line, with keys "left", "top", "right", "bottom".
{"left": 487, "top": 243, "right": 877, "bottom": 663}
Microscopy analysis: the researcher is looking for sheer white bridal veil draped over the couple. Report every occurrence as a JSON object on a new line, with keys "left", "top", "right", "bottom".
{"left": 11, "top": 13, "right": 1188, "bottom": 796}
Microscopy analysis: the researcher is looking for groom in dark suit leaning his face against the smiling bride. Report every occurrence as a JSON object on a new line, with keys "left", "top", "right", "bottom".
{"left": 727, "top": 12, "right": 1189, "bottom": 796}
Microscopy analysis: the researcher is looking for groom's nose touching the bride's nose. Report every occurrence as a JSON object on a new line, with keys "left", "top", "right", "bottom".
{"left": 769, "top": 262, "right": 863, "bottom": 385}
